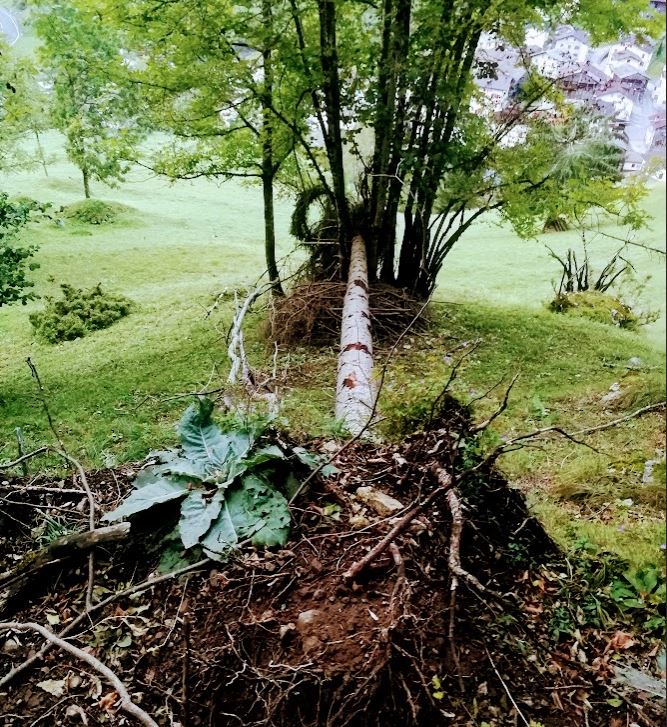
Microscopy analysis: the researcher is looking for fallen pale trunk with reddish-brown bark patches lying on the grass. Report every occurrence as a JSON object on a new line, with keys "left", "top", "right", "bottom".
{"left": 336, "top": 235, "right": 375, "bottom": 435}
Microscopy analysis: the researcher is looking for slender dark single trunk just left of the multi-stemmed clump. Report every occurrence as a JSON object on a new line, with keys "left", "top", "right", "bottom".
{"left": 262, "top": 0, "right": 284, "bottom": 295}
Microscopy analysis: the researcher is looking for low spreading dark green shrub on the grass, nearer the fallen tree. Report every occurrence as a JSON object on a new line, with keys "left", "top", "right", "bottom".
{"left": 30, "top": 284, "right": 133, "bottom": 343}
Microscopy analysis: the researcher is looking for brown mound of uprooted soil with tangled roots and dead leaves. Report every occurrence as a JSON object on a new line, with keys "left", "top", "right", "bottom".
{"left": 0, "top": 401, "right": 660, "bottom": 727}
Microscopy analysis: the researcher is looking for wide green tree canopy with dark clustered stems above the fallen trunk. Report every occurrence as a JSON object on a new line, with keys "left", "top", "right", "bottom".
{"left": 78, "top": 0, "right": 659, "bottom": 296}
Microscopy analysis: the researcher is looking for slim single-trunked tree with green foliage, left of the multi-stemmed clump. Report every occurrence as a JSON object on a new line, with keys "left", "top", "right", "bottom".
{"left": 94, "top": 0, "right": 320, "bottom": 294}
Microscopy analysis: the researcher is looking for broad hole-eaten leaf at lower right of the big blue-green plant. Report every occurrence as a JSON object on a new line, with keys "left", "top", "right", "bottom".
{"left": 201, "top": 475, "right": 290, "bottom": 560}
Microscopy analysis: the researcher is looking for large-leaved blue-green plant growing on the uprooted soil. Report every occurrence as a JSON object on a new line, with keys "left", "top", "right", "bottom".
{"left": 103, "top": 398, "right": 326, "bottom": 560}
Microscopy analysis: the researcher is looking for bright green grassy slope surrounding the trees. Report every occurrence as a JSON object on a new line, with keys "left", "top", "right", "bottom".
{"left": 0, "top": 136, "right": 665, "bottom": 563}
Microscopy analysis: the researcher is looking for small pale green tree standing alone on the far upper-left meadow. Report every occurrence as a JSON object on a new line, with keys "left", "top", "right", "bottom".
{"left": 34, "top": 2, "right": 143, "bottom": 199}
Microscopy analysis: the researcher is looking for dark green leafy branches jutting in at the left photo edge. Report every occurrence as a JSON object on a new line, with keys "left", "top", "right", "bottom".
{"left": 0, "top": 192, "right": 44, "bottom": 308}
